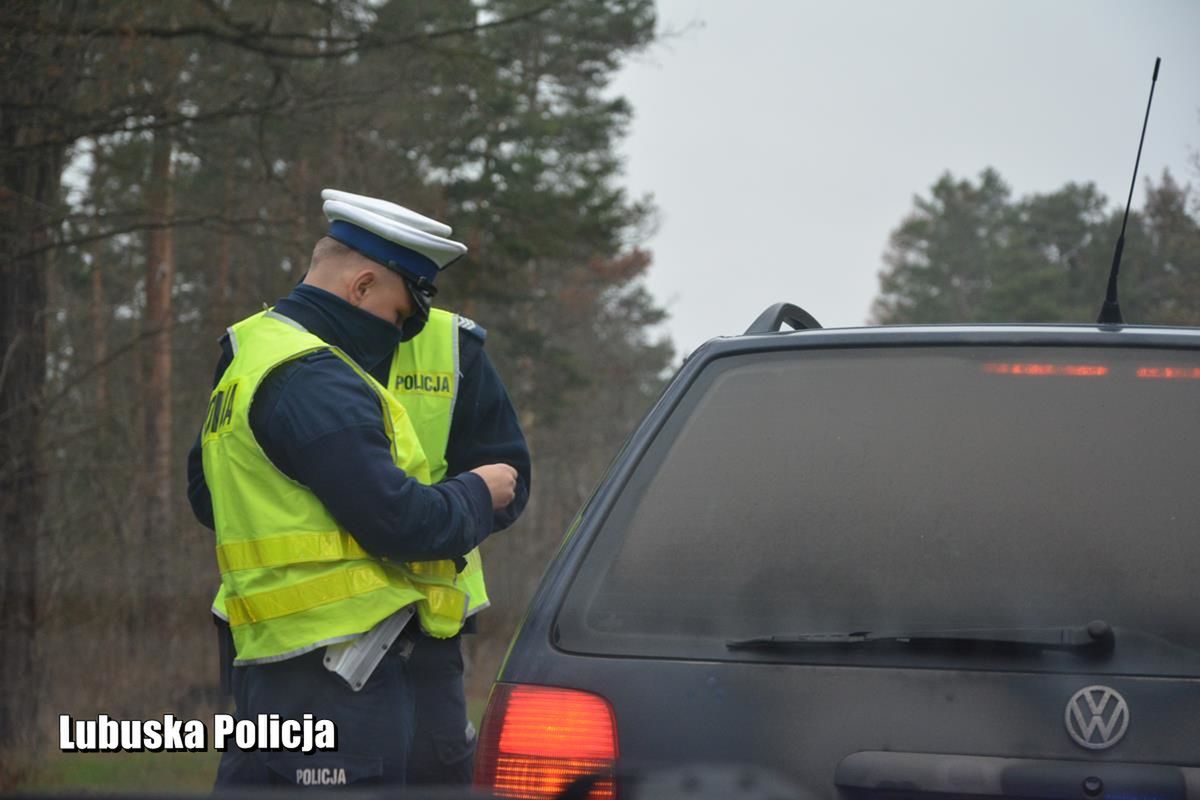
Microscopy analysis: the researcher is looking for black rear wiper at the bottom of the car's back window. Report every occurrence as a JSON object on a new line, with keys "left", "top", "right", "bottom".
{"left": 725, "top": 620, "right": 1116, "bottom": 656}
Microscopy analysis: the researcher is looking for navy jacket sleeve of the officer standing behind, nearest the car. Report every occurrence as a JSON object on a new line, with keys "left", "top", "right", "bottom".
{"left": 446, "top": 331, "right": 533, "bottom": 531}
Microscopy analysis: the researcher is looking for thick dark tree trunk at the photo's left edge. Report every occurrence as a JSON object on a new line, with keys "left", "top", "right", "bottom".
{"left": 0, "top": 2, "right": 78, "bottom": 777}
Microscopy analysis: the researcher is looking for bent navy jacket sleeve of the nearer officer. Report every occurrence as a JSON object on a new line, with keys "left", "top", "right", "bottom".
{"left": 250, "top": 351, "right": 492, "bottom": 561}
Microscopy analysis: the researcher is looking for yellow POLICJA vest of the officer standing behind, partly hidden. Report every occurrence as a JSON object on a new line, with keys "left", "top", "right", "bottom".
{"left": 388, "top": 308, "right": 490, "bottom": 615}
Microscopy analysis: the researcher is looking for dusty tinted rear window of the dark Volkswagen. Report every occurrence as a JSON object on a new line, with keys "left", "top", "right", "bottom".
{"left": 557, "top": 347, "right": 1200, "bottom": 674}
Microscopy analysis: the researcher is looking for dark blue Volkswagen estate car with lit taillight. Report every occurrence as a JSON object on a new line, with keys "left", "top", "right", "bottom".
{"left": 476, "top": 305, "right": 1200, "bottom": 800}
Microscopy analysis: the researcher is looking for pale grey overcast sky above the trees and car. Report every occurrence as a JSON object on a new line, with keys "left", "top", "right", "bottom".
{"left": 614, "top": 0, "right": 1200, "bottom": 355}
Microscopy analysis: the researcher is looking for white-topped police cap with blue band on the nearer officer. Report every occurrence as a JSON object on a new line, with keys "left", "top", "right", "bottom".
{"left": 322, "top": 190, "right": 467, "bottom": 285}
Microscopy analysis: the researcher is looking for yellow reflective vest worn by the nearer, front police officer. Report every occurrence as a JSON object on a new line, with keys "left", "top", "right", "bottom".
{"left": 202, "top": 312, "right": 468, "bottom": 663}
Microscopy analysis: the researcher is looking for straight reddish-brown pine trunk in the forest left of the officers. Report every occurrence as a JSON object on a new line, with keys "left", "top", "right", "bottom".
{"left": 139, "top": 130, "right": 175, "bottom": 625}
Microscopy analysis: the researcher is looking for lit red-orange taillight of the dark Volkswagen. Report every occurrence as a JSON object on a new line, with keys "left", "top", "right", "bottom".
{"left": 475, "top": 684, "right": 617, "bottom": 800}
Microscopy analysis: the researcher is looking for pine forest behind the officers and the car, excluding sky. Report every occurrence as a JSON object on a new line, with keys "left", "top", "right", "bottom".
{"left": 0, "top": 0, "right": 1200, "bottom": 789}
